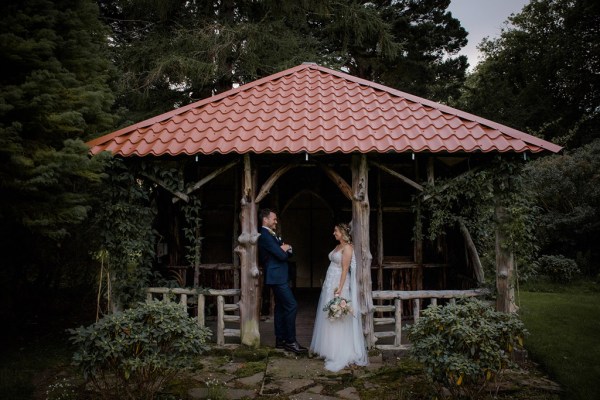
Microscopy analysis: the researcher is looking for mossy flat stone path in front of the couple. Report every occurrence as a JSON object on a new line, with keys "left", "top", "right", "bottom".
{"left": 187, "top": 347, "right": 561, "bottom": 400}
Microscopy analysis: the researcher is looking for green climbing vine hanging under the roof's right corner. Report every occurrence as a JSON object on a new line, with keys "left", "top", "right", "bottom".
{"left": 415, "top": 156, "right": 538, "bottom": 282}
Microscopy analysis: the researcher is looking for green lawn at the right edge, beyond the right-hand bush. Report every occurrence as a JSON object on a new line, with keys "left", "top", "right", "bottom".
{"left": 518, "top": 282, "right": 600, "bottom": 400}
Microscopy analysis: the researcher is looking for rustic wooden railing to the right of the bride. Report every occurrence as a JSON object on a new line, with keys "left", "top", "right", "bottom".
{"left": 372, "top": 289, "right": 489, "bottom": 350}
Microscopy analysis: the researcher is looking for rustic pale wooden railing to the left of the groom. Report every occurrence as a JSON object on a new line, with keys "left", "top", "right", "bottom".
{"left": 146, "top": 288, "right": 240, "bottom": 346}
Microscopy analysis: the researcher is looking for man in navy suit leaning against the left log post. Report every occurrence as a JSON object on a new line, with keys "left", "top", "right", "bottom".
{"left": 258, "top": 208, "right": 307, "bottom": 354}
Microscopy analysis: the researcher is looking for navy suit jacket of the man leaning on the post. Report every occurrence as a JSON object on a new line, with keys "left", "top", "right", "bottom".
{"left": 258, "top": 227, "right": 290, "bottom": 285}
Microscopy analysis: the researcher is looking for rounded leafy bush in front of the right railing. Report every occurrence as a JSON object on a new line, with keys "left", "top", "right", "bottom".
{"left": 408, "top": 299, "right": 527, "bottom": 398}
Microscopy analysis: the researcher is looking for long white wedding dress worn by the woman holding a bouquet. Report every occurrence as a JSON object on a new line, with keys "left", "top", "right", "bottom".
{"left": 310, "top": 250, "right": 369, "bottom": 372}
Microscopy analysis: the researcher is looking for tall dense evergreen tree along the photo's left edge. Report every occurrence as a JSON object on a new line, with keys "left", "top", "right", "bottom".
{"left": 0, "top": 0, "right": 115, "bottom": 322}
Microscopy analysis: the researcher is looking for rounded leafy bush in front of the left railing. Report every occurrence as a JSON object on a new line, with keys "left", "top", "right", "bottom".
{"left": 71, "top": 300, "right": 210, "bottom": 399}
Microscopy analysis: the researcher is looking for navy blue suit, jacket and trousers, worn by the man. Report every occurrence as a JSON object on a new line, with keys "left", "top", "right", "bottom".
{"left": 258, "top": 227, "right": 298, "bottom": 343}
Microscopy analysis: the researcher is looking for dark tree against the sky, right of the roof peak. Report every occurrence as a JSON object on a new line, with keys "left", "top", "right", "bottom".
{"left": 334, "top": 0, "right": 468, "bottom": 101}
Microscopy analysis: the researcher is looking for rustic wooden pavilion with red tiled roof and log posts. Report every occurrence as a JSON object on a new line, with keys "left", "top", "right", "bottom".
{"left": 88, "top": 63, "right": 560, "bottom": 347}
